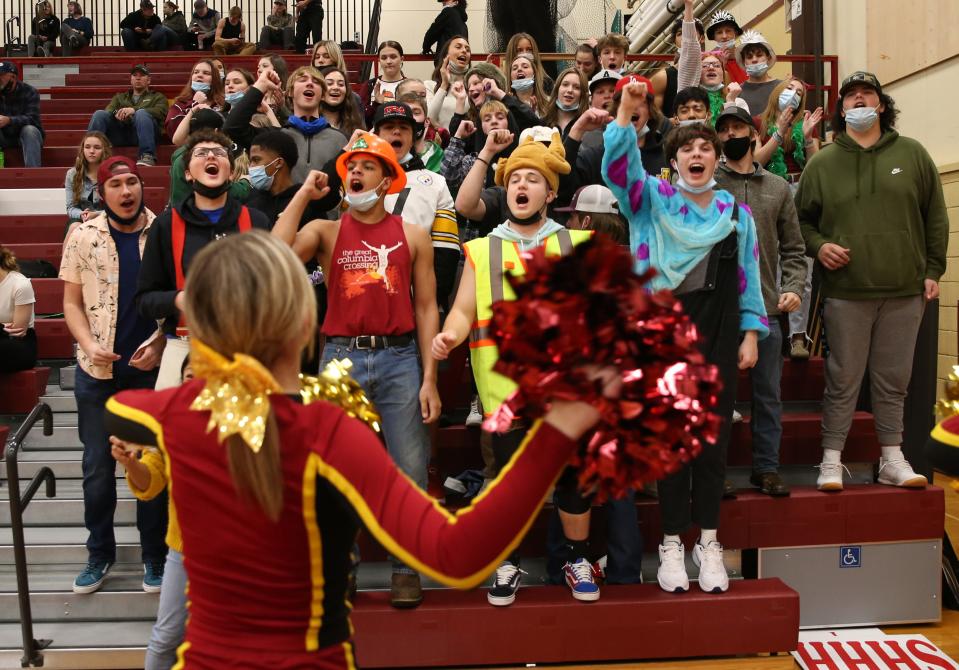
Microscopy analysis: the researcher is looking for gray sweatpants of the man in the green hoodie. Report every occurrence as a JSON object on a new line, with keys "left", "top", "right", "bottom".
{"left": 822, "top": 295, "right": 925, "bottom": 451}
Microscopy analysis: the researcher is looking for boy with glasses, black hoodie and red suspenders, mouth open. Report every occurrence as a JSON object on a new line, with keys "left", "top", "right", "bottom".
{"left": 136, "top": 130, "right": 271, "bottom": 389}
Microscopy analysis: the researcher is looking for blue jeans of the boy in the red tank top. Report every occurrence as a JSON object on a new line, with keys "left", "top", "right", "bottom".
{"left": 320, "top": 342, "right": 430, "bottom": 574}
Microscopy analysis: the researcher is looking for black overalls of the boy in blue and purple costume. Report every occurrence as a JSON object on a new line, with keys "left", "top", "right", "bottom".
{"left": 657, "top": 233, "right": 739, "bottom": 535}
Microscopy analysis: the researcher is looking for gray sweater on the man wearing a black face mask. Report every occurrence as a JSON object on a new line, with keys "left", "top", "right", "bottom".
{"left": 716, "top": 161, "right": 807, "bottom": 316}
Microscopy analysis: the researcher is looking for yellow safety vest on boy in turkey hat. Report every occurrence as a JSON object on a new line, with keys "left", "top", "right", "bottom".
{"left": 464, "top": 228, "right": 592, "bottom": 416}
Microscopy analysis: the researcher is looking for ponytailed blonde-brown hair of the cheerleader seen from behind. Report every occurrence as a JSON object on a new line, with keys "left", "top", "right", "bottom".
{"left": 184, "top": 230, "right": 316, "bottom": 521}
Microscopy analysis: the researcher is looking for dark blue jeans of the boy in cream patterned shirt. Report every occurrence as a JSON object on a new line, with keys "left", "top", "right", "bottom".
{"left": 74, "top": 365, "right": 167, "bottom": 563}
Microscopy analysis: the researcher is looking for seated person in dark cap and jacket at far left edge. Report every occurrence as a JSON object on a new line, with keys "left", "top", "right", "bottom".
{"left": 0, "top": 61, "right": 44, "bottom": 167}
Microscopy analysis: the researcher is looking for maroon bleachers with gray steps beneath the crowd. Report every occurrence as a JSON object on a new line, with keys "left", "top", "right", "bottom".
{"left": 0, "top": 49, "right": 944, "bottom": 668}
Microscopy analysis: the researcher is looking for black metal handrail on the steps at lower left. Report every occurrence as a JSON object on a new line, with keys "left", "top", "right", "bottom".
{"left": 5, "top": 403, "right": 57, "bottom": 668}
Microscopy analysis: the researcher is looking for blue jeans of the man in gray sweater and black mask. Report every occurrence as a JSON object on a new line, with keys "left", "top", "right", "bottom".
{"left": 749, "top": 317, "right": 783, "bottom": 474}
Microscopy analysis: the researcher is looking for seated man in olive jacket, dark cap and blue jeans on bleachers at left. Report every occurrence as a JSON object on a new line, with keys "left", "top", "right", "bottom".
{"left": 87, "top": 63, "right": 167, "bottom": 167}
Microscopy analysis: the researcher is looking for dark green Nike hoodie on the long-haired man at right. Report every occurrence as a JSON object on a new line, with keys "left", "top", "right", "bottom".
{"left": 796, "top": 130, "right": 949, "bottom": 300}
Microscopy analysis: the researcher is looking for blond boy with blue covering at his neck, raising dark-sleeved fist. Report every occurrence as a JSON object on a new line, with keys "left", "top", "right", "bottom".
{"left": 223, "top": 67, "right": 347, "bottom": 182}
